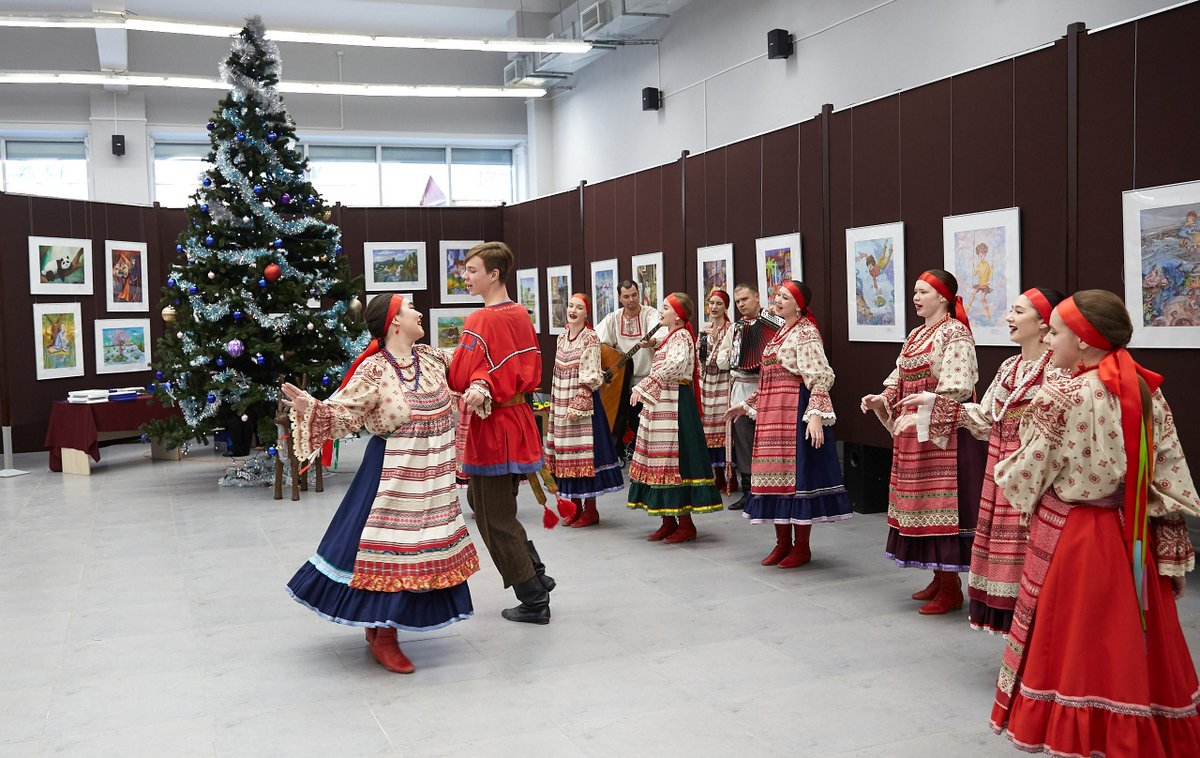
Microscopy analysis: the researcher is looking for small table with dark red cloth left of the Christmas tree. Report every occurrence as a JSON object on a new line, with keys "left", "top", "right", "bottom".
{"left": 44, "top": 396, "right": 180, "bottom": 476}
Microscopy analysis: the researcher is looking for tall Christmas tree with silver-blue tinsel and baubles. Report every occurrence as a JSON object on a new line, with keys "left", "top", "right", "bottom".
{"left": 143, "top": 17, "right": 366, "bottom": 447}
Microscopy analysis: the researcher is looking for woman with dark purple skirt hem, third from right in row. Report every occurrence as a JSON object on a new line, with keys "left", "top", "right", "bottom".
{"left": 862, "top": 269, "right": 986, "bottom": 614}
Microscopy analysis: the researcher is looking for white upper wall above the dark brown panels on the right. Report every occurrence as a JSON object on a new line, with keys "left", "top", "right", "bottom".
{"left": 547, "top": 0, "right": 1177, "bottom": 193}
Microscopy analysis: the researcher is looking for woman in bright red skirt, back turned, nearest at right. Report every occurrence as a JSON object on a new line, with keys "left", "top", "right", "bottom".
{"left": 991, "top": 289, "right": 1200, "bottom": 758}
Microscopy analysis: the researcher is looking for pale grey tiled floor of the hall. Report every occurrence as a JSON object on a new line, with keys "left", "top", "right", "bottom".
{"left": 0, "top": 443, "right": 1200, "bottom": 758}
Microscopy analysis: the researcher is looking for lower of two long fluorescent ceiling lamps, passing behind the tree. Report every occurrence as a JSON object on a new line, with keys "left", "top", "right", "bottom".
{"left": 0, "top": 71, "right": 546, "bottom": 98}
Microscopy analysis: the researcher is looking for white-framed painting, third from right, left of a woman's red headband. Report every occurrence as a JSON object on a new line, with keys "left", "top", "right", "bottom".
{"left": 846, "top": 222, "right": 908, "bottom": 342}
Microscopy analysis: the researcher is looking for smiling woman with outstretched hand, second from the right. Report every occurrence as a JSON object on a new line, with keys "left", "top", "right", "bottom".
{"left": 900, "top": 288, "right": 1063, "bottom": 634}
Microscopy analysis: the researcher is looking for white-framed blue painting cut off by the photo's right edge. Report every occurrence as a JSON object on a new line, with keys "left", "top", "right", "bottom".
{"left": 1121, "top": 181, "right": 1200, "bottom": 348}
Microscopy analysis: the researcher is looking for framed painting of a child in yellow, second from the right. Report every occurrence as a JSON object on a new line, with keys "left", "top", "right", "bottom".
{"left": 942, "top": 207, "right": 1021, "bottom": 345}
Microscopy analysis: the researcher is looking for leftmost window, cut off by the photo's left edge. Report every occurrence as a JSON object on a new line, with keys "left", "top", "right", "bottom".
{"left": 0, "top": 139, "right": 88, "bottom": 200}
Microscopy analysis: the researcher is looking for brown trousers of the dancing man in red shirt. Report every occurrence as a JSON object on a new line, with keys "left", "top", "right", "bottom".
{"left": 467, "top": 474, "right": 534, "bottom": 586}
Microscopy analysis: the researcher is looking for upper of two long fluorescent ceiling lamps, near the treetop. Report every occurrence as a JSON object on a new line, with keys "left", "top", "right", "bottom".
{"left": 0, "top": 13, "right": 592, "bottom": 55}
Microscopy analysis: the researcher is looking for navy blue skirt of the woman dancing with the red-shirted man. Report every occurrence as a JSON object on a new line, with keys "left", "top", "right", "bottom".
{"left": 287, "top": 437, "right": 475, "bottom": 632}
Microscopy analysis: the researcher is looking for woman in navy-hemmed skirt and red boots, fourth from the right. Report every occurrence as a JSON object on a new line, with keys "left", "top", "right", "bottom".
{"left": 728, "top": 281, "right": 852, "bottom": 569}
